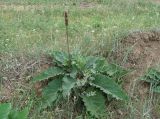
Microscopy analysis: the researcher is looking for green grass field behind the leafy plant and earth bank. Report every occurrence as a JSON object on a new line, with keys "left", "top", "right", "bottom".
{"left": 0, "top": 0, "right": 160, "bottom": 54}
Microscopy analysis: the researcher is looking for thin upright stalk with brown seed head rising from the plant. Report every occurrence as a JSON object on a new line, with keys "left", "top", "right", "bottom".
{"left": 64, "top": 11, "right": 71, "bottom": 67}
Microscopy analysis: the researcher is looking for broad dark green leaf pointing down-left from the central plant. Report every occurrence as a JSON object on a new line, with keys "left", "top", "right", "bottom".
{"left": 41, "top": 78, "right": 62, "bottom": 108}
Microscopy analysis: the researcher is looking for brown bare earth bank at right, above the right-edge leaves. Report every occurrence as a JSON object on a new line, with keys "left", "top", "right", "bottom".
{"left": 116, "top": 31, "right": 160, "bottom": 73}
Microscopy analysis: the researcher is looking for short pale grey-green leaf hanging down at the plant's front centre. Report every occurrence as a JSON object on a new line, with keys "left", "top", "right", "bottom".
{"left": 62, "top": 76, "right": 76, "bottom": 97}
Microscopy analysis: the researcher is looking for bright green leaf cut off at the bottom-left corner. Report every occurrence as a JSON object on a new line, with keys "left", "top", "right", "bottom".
{"left": 0, "top": 103, "right": 11, "bottom": 119}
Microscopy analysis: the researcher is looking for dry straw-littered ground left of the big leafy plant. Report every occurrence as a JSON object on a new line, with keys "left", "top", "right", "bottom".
{"left": 0, "top": 56, "right": 51, "bottom": 102}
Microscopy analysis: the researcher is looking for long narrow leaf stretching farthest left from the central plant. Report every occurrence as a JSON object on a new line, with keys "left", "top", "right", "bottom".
{"left": 33, "top": 67, "right": 64, "bottom": 82}
